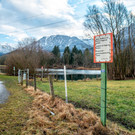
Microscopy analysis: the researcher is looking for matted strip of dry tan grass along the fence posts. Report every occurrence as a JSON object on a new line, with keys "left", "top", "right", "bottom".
{"left": 22, "top": 87, "right": 133, "bottom": 135}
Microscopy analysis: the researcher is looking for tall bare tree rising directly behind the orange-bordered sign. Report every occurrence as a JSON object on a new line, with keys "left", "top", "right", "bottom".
{"left": 84, "top": 0, "right": 129, "bottom": 79}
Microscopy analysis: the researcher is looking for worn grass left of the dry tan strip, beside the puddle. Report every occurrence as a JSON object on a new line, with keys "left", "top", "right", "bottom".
{"left": 0, "top": 75, "right": 32, "bottom": 135}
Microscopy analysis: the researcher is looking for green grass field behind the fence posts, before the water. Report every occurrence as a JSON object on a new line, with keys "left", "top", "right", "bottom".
{"left": 37, "top": 80, "right": 135, "bottom": 130}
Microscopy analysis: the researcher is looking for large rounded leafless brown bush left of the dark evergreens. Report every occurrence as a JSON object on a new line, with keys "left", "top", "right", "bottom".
{"left": 6, "top": 38, "right": 51, "bottom": 75}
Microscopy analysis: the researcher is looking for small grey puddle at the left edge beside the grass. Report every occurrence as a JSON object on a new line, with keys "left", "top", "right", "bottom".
{"left": 0, "top": 81, "right": 10, "bottom": 104}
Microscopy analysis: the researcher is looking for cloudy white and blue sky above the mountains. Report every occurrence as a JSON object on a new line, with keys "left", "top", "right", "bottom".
{"left": 0, "top": 0, "right": 135, "bottom": 44}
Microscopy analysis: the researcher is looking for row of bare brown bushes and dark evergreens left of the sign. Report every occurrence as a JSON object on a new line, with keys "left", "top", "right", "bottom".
{"left": 0, "top": 38, "right": 93, "bottom": 75}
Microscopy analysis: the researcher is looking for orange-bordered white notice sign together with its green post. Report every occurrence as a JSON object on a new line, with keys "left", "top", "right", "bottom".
{"left": 94, "top": 33, "right": 113, "bottom": 126}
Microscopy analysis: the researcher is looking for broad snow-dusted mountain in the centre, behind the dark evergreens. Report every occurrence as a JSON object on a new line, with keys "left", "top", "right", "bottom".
{"left": 38, "top": 35, "right": 93, "bottom": 52}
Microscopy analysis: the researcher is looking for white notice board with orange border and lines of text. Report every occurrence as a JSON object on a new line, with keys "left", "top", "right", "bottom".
{"left": 94, "top": 33, "right": 113, "bottom": 63}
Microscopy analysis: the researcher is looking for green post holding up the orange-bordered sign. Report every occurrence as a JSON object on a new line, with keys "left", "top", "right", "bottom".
{"left": 100, "top": 63, "right": 107, "bottom": 126}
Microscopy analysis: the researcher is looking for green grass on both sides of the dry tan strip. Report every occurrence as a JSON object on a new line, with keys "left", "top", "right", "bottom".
{"left": 0, "top": 75, "right": 135, "bottom": 135}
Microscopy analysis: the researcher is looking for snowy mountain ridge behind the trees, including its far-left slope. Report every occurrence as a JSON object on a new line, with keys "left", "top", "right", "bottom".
{"left": 0, "top": 35, "right": 93, "bottom": 56}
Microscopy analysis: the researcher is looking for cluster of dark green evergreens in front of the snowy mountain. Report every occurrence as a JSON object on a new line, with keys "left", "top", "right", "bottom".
{"left": 52, "top": 46, "right": 93, "bottom": 68}
